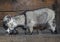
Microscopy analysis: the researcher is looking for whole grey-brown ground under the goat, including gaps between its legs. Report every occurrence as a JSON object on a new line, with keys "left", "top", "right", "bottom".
{"left": 0, "top": 27, "right": 60, "bottom": 42}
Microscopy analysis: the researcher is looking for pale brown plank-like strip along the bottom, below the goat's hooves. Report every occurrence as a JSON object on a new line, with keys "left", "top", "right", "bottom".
{"left": 0, "top": 35, "right": 60, "bottom": 42}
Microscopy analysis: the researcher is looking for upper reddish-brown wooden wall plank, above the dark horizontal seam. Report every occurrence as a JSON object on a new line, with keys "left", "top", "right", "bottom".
{"left": 0, "top": 0, "right": 54, "bottom": 11}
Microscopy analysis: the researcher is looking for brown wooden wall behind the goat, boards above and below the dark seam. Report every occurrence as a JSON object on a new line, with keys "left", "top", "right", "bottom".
{"left": 0, "top": 0, "right": 55, "bottom": 26}
